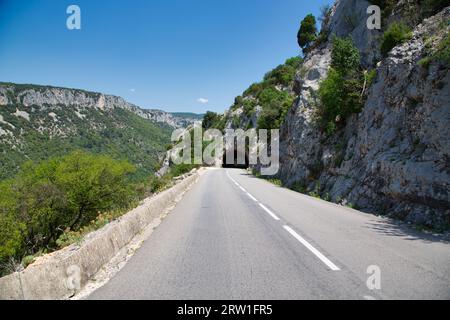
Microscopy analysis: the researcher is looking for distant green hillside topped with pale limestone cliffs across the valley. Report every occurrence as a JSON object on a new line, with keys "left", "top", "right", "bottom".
{"left": 0, "top": 83, "right": 191, "bottom": 179}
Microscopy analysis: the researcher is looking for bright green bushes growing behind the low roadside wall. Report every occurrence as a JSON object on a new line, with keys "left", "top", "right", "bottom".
{"left": 0, "top": 151, "right": 197, "bottom": 275}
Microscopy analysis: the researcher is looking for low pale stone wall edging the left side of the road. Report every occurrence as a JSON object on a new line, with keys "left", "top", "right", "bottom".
{"left": 0, "top": 173, "right": 199, "bottom": 300}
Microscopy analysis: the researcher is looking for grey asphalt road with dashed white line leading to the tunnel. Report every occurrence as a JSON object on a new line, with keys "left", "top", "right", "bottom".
{"left": 89, "top": 169, "right": 450, "bottom": 299}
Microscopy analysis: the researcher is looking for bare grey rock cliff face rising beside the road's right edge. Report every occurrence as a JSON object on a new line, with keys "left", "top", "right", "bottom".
{"left": 229, "top": 0, "right": 450, "bottom": 230}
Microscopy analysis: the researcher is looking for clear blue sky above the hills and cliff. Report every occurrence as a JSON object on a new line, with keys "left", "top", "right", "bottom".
{"left": 0, "top": 0, "right": 332, "bottom": 113}
